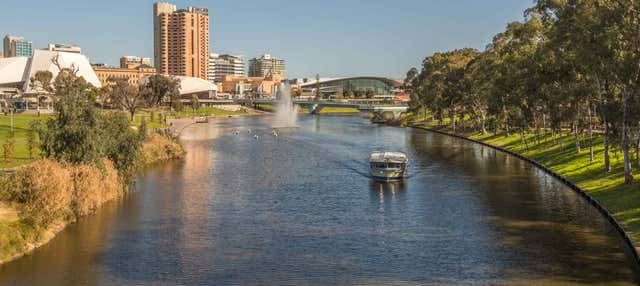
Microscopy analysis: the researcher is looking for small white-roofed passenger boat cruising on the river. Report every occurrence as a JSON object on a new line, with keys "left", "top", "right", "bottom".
{"left": 369, "top": 151, "right": 409, "bottom": 181}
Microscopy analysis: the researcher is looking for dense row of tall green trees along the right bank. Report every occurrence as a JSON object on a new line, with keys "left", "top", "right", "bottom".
{"left": 404, "top": 0, "right": 640, "bottom": 183}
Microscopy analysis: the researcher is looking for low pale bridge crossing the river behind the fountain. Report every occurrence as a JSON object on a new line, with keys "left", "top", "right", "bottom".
{"left": 240, "top": 98, "right": 409, "bottom": 117}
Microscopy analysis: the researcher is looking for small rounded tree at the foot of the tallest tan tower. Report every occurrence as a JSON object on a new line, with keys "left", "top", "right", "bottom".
{"left": 142, "top": 74, "right": 180, "bottom": 108}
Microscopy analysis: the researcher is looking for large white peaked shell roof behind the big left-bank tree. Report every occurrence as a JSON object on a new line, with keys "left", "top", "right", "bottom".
{"left": 24, "top": 50, "right": 101, "bottom": 93}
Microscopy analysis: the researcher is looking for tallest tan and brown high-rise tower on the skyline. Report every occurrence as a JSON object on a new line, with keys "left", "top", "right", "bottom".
{"left": 153, "top": 2, "right": 209, "bottom": 80}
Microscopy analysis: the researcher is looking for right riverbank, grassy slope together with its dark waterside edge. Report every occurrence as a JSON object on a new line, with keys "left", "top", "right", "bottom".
{"left": 408, "top": 122, "right": 640, "bottom": 259}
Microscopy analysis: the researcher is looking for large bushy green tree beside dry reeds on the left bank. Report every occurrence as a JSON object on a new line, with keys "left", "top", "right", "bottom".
{"left": 40, "top": 70, "right": 140, "bottom": 181}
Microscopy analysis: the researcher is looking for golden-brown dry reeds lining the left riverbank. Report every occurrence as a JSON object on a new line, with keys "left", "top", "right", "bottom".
{"left": 0, "top": 134, "right": 185, "bottom": 264}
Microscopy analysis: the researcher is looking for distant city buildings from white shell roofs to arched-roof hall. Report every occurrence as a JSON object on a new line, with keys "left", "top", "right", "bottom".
{"left": 0, "top": 2, "right": 398, "bottom": 107}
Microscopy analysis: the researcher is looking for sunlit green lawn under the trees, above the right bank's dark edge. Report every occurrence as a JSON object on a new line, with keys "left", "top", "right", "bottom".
{"left": 417, "top": 115, "right": 640, "bottom": 241}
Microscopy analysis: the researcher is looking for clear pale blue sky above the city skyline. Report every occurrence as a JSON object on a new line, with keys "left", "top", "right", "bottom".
{"left": 0, "top": 0, "right": 533, "bottom": 78}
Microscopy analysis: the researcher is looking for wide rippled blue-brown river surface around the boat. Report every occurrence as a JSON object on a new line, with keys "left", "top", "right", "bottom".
{"left": 0, "top": 116, "right": 635, "bottom": 285}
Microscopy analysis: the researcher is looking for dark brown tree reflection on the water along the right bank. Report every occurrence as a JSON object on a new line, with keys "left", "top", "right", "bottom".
{"left": 409, "top": 130, "right": 633, "bottom": 283}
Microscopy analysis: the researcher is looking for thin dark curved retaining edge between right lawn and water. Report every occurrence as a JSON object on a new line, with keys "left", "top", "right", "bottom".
{"left": 406, "top": 124, "right": 640, "bottom": 273}
